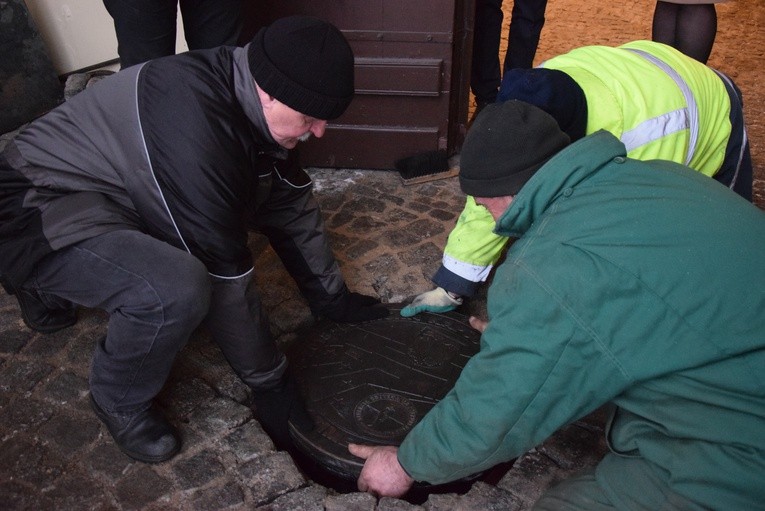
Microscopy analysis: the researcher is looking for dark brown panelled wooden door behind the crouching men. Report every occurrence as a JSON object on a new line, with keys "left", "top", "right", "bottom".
{"left": 243, "top": 0, "right": 473, "bottom": 169}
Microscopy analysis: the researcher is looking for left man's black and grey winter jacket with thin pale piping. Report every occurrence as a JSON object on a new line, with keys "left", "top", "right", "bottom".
{"left": 0, "top": 47, "right": 347, "bottom": 316}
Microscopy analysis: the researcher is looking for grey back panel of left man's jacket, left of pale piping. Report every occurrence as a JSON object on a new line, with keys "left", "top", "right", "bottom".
{"left": 15, "top": 66, "right": 182, "bottom": 250}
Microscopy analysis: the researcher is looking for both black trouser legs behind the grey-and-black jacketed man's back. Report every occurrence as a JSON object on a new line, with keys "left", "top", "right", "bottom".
{"left": 104, "top": 0, "right": 243, "bottom": 68}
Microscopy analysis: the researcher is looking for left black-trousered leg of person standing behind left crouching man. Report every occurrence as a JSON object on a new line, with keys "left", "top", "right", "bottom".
{"left": 104, "top": 0, "right": 178, "bottom": 69}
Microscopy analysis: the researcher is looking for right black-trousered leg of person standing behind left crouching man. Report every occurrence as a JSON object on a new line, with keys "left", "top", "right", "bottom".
{"left": 180, "top": 0, "right": 244, "bottom": 50}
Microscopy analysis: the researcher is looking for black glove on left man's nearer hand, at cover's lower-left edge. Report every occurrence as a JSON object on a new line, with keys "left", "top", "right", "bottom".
{"left": 252, "top": 373, "right": 316, "bottom": 451}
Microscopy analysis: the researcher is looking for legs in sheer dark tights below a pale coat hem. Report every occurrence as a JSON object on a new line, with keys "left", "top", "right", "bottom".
{"left": 652, "top": 1, "right": 717, "bottom": 64}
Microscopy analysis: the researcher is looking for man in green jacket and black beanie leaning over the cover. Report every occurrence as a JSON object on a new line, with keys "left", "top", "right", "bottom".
{"left": 349, "top": 101, "right": 765, "bottom": 511}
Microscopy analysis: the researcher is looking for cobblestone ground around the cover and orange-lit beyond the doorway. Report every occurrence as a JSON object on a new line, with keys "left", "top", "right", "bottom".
{"left": 0, "top": 0, "right": 765, "bottom": 511}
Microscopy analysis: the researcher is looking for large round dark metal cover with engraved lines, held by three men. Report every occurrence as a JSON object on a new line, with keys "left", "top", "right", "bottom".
{"left": 287, "top": 305, "right": 481, "bottom": 479}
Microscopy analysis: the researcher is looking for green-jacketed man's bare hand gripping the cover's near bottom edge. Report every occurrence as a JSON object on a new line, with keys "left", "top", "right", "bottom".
{"left": 348, "top": 444, "right": 414, "bottom": 497}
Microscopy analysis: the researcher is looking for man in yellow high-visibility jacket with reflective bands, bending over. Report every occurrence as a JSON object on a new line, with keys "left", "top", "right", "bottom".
{"left": 401, "top": 41, "right": 752, "bottom": 316}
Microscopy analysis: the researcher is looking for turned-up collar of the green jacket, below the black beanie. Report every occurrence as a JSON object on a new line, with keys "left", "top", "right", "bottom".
{"left": 494, "top": 130, "right": 627, "bottom": 238}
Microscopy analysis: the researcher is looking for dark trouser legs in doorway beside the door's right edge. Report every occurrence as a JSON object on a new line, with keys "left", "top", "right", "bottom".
{"left": 470, "top": 0, "right": 547, "bottom": 103}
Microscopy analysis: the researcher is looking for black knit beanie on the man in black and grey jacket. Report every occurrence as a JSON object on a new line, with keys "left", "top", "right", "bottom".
{"left": 247, "top": 16, "right": 354, "bottom": 120}
